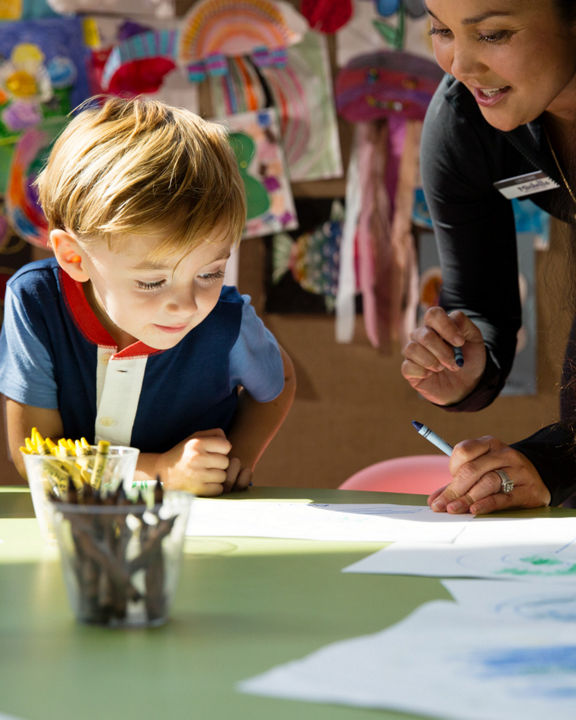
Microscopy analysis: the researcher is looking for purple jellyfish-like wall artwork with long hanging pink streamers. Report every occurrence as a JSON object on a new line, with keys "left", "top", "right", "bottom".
{"left": 335, "top": 50, "right": 442, "bottom": 352}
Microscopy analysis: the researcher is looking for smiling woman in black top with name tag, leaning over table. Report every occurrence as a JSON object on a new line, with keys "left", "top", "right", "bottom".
{"left": 402, "top": 0, "right": 576, "bottom": 512}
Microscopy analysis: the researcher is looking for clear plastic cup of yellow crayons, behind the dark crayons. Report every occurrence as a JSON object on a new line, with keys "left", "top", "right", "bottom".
{"left": 22, "top": 445, "right": 139, "bottom": 542}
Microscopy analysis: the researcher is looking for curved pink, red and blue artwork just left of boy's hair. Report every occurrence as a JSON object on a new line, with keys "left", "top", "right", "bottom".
{"left": 6, "top": 129, "right": 51, "bottom": 247}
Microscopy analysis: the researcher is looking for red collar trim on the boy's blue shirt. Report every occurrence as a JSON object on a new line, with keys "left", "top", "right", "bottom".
{"left": 59, "top": 268, "right": 162, "bottom": 359}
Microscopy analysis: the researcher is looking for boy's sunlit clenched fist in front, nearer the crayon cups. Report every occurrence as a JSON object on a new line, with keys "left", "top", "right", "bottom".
{"left": 158, "top": 428, "right": 233, "bottom": 497}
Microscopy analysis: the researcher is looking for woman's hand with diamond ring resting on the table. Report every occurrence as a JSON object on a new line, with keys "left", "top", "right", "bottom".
{"left": 428, "top": 435, "right": 551, "bottom": 515}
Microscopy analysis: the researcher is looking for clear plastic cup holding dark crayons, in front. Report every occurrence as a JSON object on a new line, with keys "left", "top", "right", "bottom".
{"left": 50, "top": 488, "right": 193, "bottom": 628}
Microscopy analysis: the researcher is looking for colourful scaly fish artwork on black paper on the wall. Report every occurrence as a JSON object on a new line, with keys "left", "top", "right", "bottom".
{"left": 266, "top": 198, "right": 344, "bottom": 314}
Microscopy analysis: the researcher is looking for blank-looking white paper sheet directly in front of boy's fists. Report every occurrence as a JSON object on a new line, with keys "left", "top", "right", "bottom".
{"left": 186, "top": 499, "right": 472, "bottom": 543}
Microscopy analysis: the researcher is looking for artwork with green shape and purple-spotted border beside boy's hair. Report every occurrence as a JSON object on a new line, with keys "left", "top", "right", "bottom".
{"left": 222, "top": 108, "right": 298, "bottom": 237}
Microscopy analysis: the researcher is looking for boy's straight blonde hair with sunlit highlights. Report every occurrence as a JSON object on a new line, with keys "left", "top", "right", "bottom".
{"left": 36, "top": 97, "right": 246, "bottom": 251}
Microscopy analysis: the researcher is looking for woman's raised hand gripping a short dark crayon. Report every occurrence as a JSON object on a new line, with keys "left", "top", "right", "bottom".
{"left": 401, "top": 307, "right": 486, "bottom": 405}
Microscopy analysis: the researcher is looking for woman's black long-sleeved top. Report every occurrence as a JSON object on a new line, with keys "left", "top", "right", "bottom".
{"left": 421, "top": 76, "right": 576, "bottom": 504}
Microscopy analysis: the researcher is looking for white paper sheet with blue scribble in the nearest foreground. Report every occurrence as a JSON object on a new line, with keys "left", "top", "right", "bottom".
{"left": 239, "top": 596, "right": 576, "bottom": 720}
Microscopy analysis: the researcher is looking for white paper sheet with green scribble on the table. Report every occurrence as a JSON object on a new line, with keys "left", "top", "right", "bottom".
{"left": 344, "top": 518, "right": 576, "bottom": 583}
